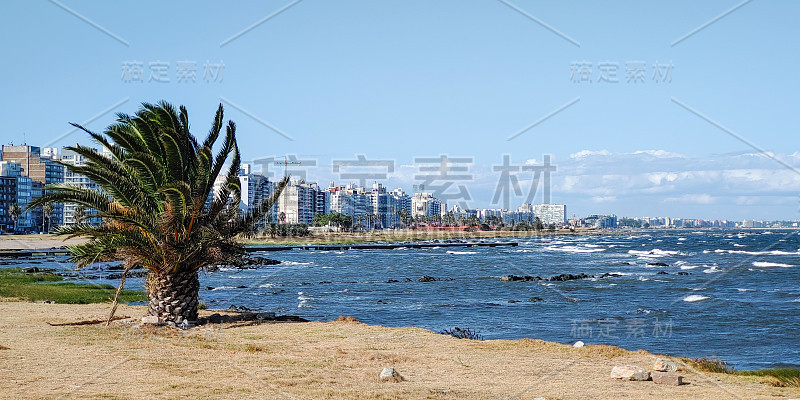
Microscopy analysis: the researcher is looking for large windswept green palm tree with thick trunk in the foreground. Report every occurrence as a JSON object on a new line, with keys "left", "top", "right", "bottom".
{"left": 29, "top": 101, "right": 287, "bottom": 324}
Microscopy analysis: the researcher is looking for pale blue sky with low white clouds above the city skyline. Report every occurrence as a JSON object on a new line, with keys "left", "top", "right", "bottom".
{"left": 0, "top": 0, "right": 800, "bottom": 219}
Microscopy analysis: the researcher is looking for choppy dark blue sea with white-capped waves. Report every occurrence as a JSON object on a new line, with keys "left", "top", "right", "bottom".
{"left": 0, "top": 230, "right": 800, "bottom": 369}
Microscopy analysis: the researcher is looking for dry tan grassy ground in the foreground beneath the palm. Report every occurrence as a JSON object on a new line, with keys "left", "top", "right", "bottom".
{"left": 0, "top": 302, "right": 800, "bottom": 400}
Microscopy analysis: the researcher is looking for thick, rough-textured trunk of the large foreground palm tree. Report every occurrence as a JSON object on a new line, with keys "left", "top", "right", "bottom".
{"left": 147, "top": 271, "right": 200, "bottom": 324}
